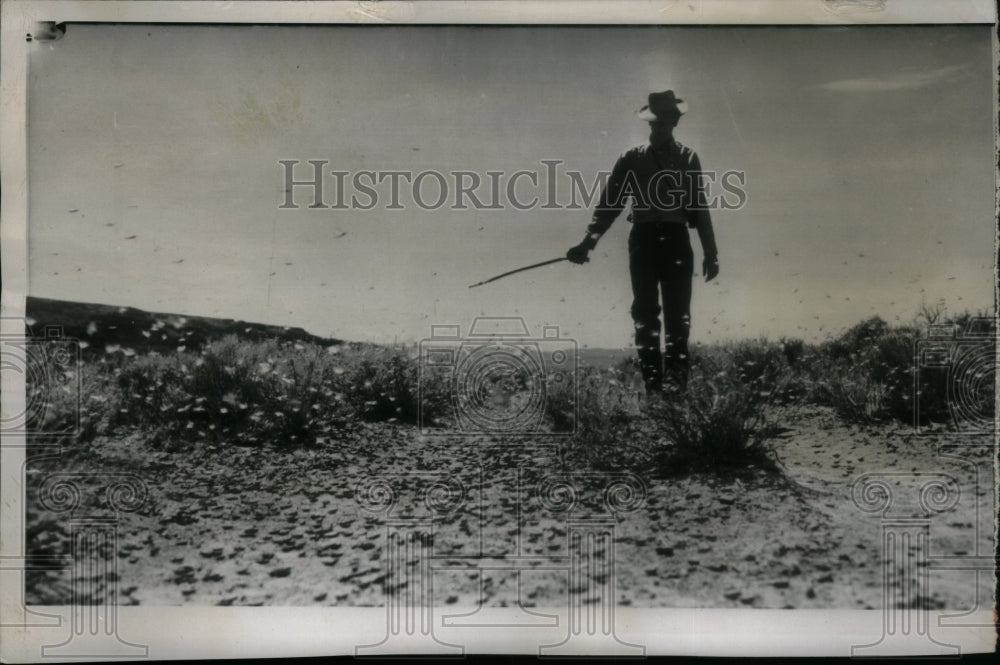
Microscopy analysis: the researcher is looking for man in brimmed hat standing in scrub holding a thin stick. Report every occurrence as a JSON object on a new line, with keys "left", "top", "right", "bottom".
{"left": 566, "top": 90, "right": 719, "bottom": 394}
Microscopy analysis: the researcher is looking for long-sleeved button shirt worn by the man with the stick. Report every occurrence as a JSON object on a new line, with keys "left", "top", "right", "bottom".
{"left": 587, "top": 140, "right": 717, "bottom": 259}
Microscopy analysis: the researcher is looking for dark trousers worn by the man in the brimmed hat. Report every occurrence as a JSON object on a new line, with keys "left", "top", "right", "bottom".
{"left": 628, "top": 223, "right": 694, "bottom": 392}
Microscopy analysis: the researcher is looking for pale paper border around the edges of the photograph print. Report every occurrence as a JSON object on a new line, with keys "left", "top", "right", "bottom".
{"left": 0, "top": 0, "right": 998, "bottom": 662}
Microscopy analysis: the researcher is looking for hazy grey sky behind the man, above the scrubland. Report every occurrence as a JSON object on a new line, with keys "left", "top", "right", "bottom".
{"left": 28, "top": 25, "right": 995, "bottom": 348}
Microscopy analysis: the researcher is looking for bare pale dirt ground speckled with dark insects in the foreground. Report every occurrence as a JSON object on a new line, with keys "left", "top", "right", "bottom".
{"left": 21, "top": 407, "right": 994, "bottom": 610}
